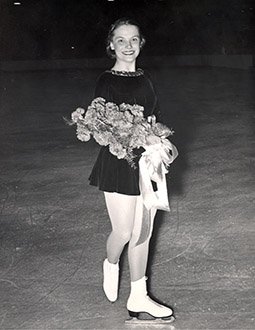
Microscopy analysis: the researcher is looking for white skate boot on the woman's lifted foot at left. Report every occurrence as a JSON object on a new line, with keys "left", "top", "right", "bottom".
{"left": 103, "top": 259, "right": 119, "bottom": 302}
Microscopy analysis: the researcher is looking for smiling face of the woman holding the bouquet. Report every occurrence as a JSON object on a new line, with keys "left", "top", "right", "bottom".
{"left": 110, "top": 25, "right": 140, "bottom": 63}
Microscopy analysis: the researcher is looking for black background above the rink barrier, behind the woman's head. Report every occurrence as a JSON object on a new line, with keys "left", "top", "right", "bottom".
{"left": 0, "top": 0, "right": 255, "bottom": 60}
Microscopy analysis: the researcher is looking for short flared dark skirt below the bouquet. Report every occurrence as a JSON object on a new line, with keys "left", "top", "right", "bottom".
{"left": 89, "top": 146, "right": 140, "bottom": 195}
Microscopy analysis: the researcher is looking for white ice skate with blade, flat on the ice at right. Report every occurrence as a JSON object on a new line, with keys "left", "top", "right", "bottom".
{"left": 126, "top": 277, "right": 174, "bottom": 323}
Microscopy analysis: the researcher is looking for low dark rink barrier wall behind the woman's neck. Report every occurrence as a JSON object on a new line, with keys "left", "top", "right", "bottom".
{"left": 0, "top": 54, "right": 255, "bottom": 71}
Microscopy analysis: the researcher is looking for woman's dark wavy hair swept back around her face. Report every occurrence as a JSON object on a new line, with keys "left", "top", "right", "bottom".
{"left": 106, "top": 17, "right": 145, "bottom": 58}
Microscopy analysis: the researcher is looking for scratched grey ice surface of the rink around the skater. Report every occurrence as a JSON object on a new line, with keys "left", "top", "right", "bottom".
{"left": 0, "top": 68, "right": 255, "bottom": 330}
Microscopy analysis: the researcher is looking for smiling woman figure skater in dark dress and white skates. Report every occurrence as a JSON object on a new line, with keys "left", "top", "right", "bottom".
{"left": 89, "top": 19, "right": 173, "bottom": 318}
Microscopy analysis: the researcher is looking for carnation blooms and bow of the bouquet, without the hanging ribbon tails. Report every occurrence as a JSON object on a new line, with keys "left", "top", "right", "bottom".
{"left": 71, "top": 97, "right": 175, "bottom": 170}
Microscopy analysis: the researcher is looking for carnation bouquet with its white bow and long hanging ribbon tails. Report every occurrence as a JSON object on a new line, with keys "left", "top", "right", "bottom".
{"left": 68, "top": 97, "right": 178, "bottom": 211}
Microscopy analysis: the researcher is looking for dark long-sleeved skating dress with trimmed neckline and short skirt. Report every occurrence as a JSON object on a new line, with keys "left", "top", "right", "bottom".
{"left": 89, "top": 69, "right": 159, "bottom": 195}
